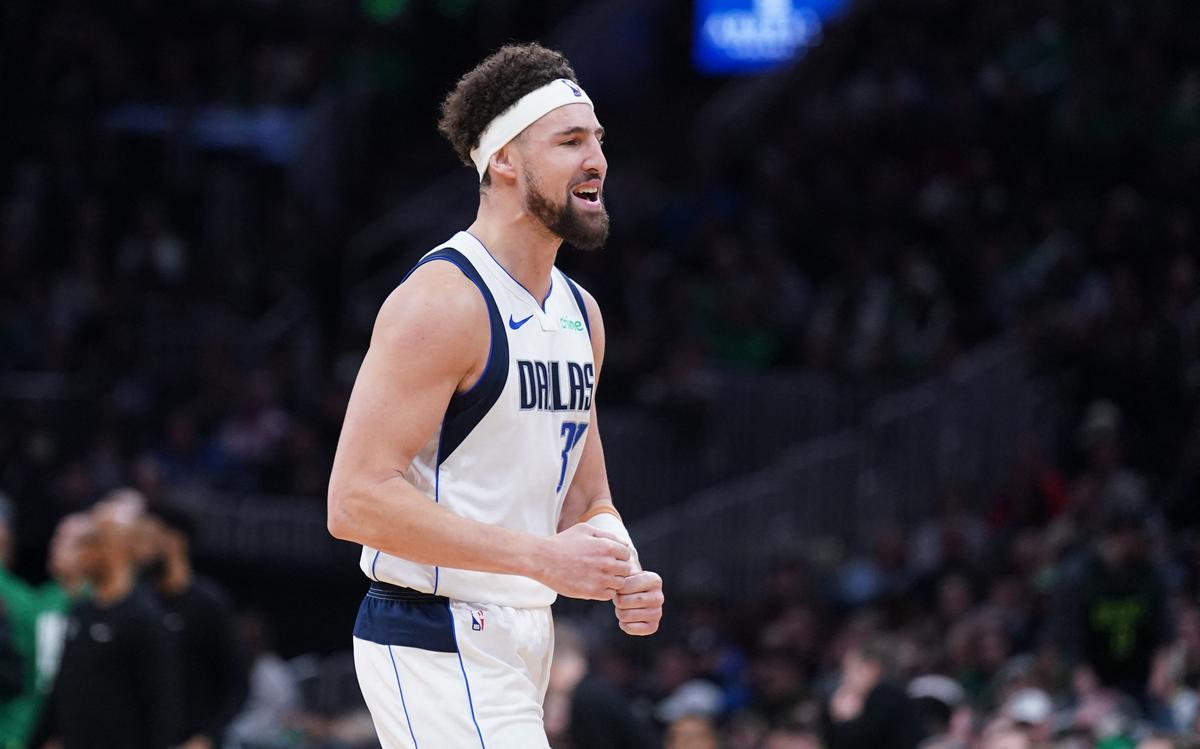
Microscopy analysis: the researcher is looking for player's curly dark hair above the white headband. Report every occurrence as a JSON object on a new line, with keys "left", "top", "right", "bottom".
{"left": 438, "top": 42, "right": 578, "bottom": 185}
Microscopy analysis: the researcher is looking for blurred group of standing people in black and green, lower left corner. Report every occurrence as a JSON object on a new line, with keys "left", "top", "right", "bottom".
{"left": 0, "top": 489, "right": 378, "bottom": 749}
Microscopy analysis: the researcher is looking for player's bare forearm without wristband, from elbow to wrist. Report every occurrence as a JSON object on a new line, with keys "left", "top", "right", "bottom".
{"left": 329, "top": 477, "right": 544, "bottom": 577}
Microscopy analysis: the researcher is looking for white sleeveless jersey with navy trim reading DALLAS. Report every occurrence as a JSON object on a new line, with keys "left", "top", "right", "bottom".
{"left": 360, "top": 232, "right": 595, "bottom": 607}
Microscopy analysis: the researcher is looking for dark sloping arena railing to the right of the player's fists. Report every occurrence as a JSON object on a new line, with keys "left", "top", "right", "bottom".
{"left": 631, "top": 341, "right": 1052, "bottom": 594}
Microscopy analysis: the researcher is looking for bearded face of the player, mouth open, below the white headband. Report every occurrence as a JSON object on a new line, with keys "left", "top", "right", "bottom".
{"left": 512, "top": 104, "right": 608, "bottom": 250}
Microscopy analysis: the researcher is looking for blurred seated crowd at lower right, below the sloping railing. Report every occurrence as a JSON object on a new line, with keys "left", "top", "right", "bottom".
{"left": 547, "top": 401, "right": 1200, "bottom": 749}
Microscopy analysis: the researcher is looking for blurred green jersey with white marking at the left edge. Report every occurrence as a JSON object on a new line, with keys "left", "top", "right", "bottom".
{"left": 0, "top": 569, "right": 71, "bottom": 749}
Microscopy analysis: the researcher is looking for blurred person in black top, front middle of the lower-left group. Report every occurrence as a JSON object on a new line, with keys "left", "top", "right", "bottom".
{"left": 30, "top": 508, "right": 178, "bottom": 749}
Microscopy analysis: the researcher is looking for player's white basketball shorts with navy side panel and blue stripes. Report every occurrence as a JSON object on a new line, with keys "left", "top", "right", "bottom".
{"left": 354, "top": 582, "right": 554, "bottom": 749}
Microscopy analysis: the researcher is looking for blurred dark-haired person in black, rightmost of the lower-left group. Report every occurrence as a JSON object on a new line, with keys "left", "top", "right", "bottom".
{"left": 150, "top": 505, "right": 247, "bottom": 749}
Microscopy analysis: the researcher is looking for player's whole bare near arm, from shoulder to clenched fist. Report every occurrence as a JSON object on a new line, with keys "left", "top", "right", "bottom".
{"left": 328, "top": 262, "right": 629, "bottom": 599}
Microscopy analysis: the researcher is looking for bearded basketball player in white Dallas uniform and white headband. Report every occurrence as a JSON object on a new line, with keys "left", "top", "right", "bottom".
{"left": 329, "top": 44, "right": 662, "bottom": 749}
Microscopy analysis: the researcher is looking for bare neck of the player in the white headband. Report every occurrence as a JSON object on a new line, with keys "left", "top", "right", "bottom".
{"left": 467, "top": 199, "right": 563, "bottom": 306}
